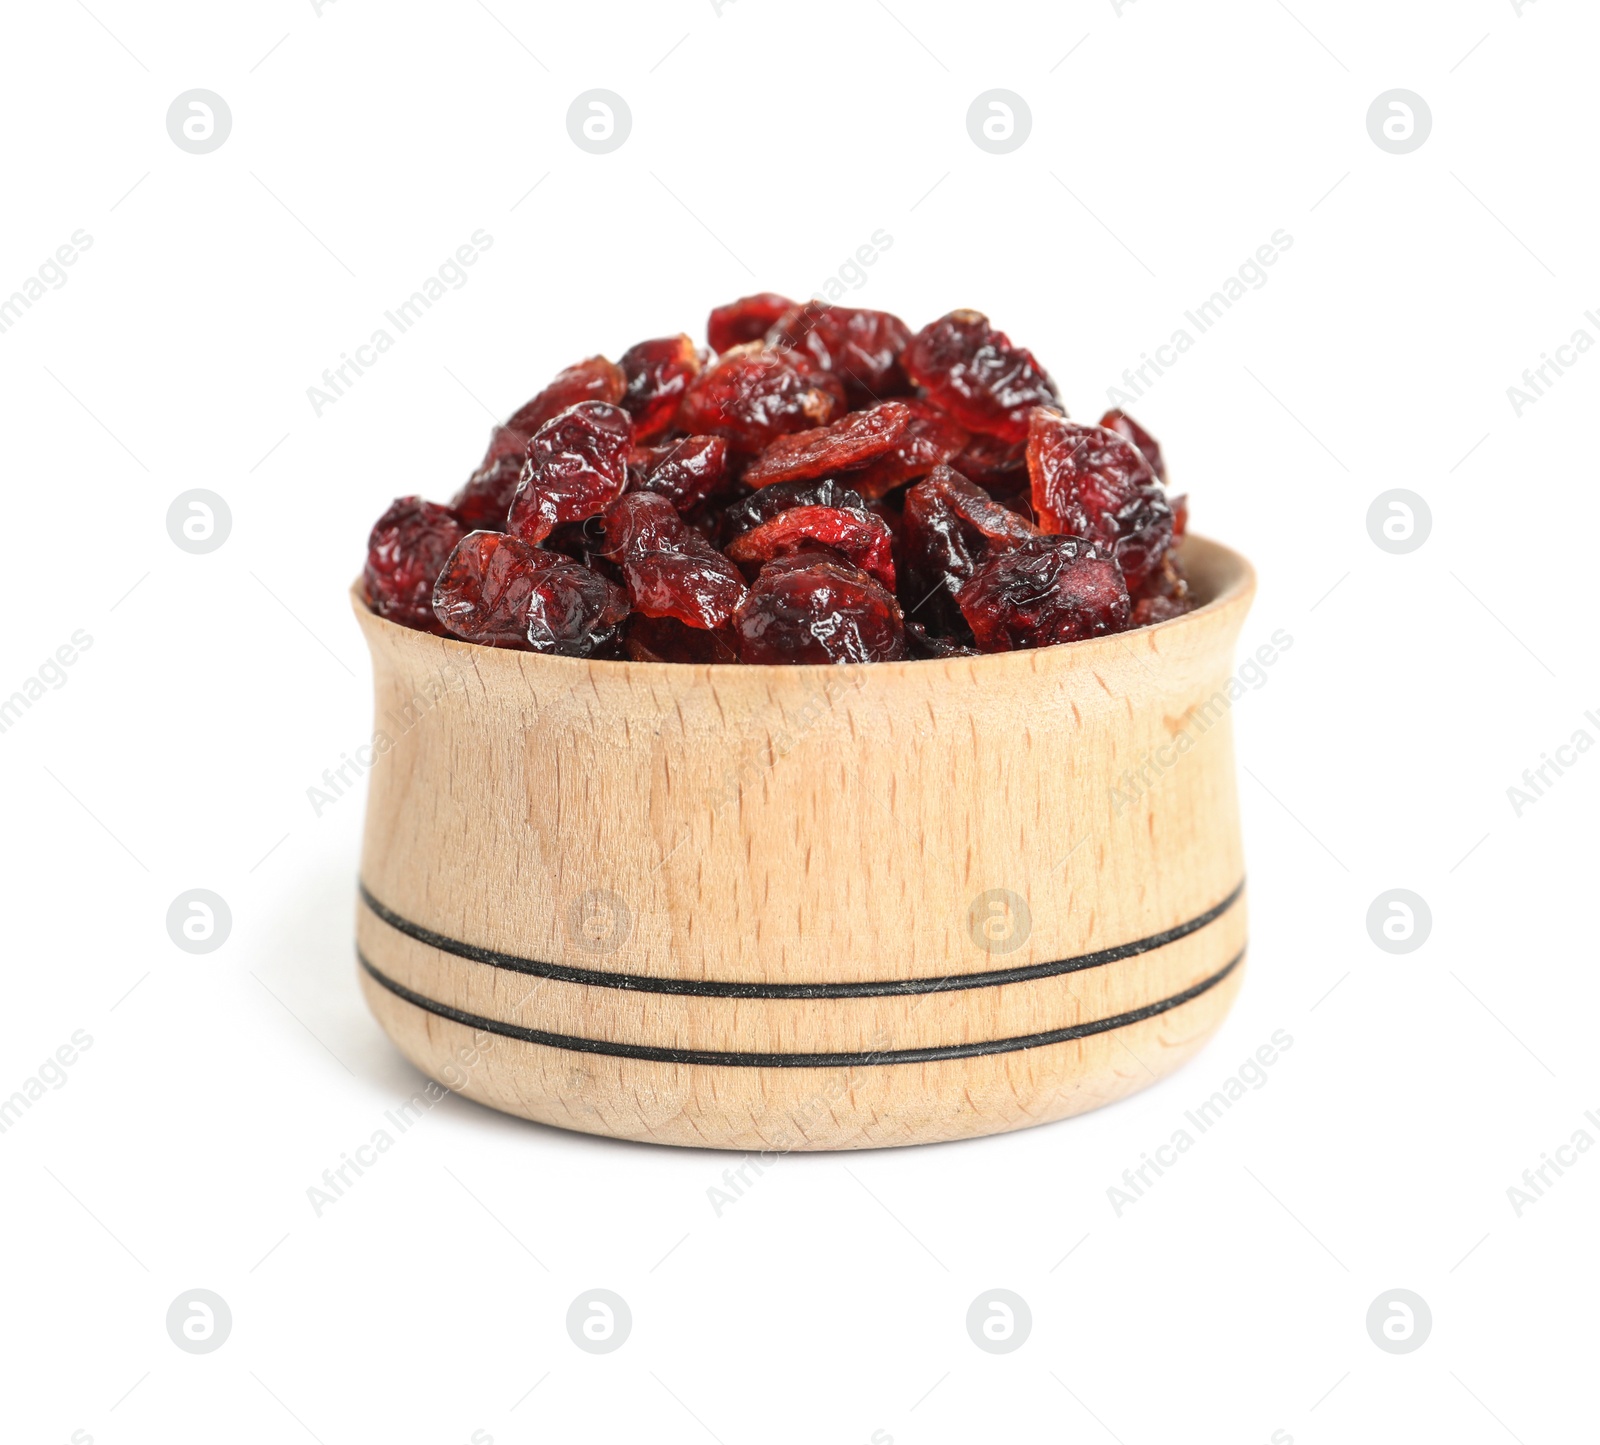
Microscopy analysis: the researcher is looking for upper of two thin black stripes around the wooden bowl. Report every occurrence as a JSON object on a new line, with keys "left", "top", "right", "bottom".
{"left": 360, "top": 879, "right": 1245, "bottom": 999}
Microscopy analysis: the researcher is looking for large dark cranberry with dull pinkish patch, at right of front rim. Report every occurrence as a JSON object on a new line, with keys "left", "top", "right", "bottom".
{"left": 955, "top": 536, "right": 1131, "bottom": 653}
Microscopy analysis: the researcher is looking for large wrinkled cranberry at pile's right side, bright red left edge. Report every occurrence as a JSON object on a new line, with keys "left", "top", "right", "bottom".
{"left": 1027, "top": 410, "right": 1173, "bottom": 589}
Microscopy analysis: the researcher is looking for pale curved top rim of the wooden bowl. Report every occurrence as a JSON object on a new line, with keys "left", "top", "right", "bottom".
{"left": 350, "top": 531, "right": 1256, "bottom": 680}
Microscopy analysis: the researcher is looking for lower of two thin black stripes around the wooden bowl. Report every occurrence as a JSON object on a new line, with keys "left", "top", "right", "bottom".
{"left": 355, "top": 949, "right": 1245, "bottom": 1069}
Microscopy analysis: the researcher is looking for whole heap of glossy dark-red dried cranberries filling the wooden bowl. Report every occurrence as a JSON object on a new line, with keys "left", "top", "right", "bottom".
{"left": 366, "top": 305, "right": 1194, "bottom": 662}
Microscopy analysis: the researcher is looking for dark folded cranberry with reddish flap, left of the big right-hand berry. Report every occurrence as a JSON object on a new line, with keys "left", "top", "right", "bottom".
{"left": 904, "top": 466, "right": 1038, "bottom": 627}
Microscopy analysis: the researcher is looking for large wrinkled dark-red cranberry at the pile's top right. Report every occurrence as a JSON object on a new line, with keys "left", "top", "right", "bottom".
{"left": 901, "top": 310, "right": 1061, "bottom": 442}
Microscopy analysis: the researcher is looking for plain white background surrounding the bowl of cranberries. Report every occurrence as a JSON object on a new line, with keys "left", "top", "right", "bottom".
{"left": 0, "top": 0, "right": 1600, "bottom": 1445}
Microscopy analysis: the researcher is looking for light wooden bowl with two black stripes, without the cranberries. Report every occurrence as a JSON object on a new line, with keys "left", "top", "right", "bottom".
{"left": 354, "top": 538, "right": 1254, "bottom": 1152}
